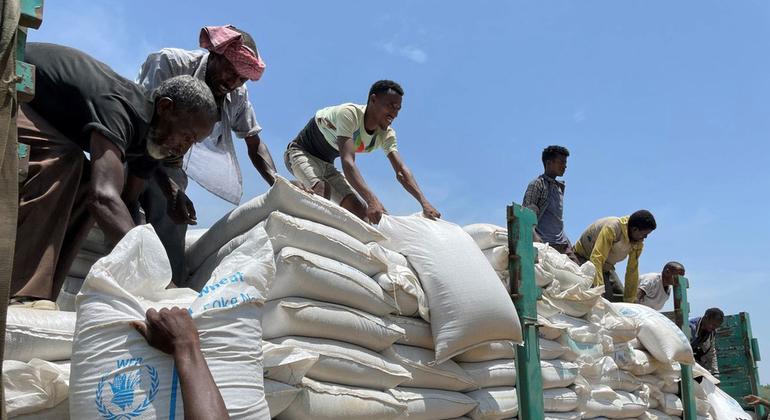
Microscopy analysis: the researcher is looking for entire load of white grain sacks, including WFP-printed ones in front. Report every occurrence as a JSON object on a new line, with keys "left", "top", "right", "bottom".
{"left": 4, "top": 179, "right": 743, "bottom": 420}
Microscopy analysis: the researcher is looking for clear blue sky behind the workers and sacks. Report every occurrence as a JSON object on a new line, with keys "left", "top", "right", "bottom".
{"left": 30, "top": 0, "right": 770, "bottom": 382}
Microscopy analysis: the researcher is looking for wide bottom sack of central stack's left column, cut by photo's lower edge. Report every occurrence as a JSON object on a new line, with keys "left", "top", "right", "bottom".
{"left": 278, "top": 379, "right": 407, "bottom": 420}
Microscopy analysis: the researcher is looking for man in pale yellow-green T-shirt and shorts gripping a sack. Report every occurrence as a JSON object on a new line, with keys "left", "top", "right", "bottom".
{"left": 284, "top": 80, "right": 441, "bottom": 223}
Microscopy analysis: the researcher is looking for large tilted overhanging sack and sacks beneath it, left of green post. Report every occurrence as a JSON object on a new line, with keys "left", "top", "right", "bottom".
{"left": 379, "top": 216, "right": 521, "bottom": 419}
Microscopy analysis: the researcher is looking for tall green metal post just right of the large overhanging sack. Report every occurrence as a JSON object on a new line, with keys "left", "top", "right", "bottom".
{"left": 507, "top": 203, "right": 544, "bottom": 420}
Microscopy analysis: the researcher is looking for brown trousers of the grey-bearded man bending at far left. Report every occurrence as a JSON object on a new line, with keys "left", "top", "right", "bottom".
{"left": 11, "top": 106, "right": 85, "bottom": 300}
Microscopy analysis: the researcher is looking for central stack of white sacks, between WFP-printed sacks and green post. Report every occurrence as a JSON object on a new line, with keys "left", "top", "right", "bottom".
{"left": 188, "top": 180, "right": 521, "bottom": 420}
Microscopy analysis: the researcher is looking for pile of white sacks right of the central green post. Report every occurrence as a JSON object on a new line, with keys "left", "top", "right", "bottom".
{"left": 458, "top": 224, "right": 752, "bottom": 420}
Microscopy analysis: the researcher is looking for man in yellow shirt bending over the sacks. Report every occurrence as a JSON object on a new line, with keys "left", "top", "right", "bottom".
{"left": 575, "top": 210, "right": 657, "bottom": 303}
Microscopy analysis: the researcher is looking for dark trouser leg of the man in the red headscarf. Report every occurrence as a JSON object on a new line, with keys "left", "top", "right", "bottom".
{"left": 139, "top": 167, "right": 188, "bottom": 285}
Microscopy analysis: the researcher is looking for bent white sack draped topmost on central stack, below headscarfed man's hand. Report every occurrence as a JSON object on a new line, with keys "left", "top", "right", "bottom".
{"left": 185, "top": 177, "right": 384, "bottom": 272}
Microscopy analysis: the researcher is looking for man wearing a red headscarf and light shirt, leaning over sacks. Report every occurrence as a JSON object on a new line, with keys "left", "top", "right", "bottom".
{"left": 133, "top": 25, "right": 277, "bottom": 285}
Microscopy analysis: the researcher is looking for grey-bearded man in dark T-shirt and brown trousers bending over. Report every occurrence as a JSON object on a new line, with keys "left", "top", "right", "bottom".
{"left": 11, "top": 43, "right": 217, "bottom": 308}
